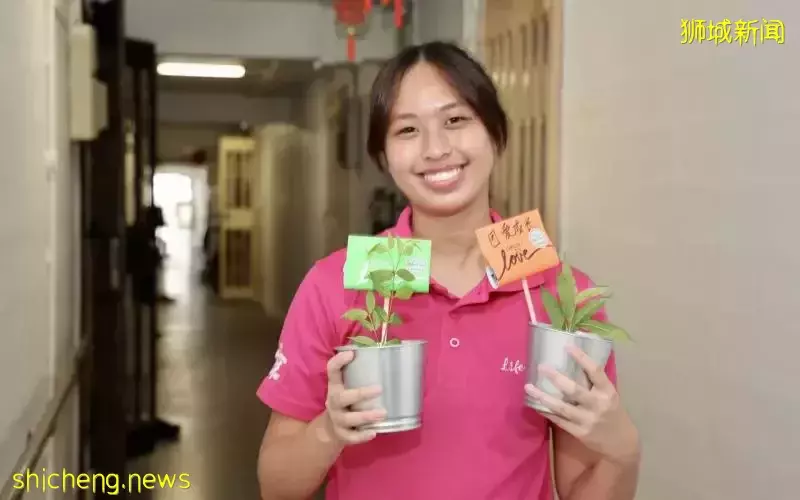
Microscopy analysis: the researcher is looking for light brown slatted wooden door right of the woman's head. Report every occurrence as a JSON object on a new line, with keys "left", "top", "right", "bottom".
{"left": 480, "top": 0, "right": 562, "bottom": 241}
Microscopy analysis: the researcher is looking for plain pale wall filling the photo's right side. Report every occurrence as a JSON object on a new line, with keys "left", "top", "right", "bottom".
{"left": 562, "top": 0, "right": 800, "bottom": 500}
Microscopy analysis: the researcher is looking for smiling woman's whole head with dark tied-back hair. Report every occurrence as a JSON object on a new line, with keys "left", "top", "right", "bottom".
{"left": 367, "top": 43, "right": 508, "bottom": 219}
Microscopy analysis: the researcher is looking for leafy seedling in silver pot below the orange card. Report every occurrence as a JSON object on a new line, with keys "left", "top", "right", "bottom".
{"left": 526, "top": 262, "right": 630, "bottom": 413}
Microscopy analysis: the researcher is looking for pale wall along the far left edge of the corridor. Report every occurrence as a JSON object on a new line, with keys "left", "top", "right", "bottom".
{"left": 0, "top": 0, "right": 79, "bottom": 498}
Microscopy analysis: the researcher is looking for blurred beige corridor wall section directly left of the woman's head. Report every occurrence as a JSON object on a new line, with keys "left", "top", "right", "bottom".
{"left": 256, "top": 63, "right": 400, "bottom": 316}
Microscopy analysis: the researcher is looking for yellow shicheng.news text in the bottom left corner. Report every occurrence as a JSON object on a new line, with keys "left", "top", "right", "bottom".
{"left": 11, "top": 469, "right": 191, "bottom": 495}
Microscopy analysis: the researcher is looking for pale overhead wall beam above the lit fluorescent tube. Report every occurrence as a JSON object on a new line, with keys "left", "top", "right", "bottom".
{"left": 125, "top": 0, "right": 397, "bottom": 63}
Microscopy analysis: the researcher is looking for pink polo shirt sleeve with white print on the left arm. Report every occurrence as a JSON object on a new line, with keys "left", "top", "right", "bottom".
{"left": 257, "top": 263, "right": 336, "bottom": 422}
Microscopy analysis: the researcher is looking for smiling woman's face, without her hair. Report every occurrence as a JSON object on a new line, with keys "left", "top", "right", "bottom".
{"left": 386, "top": 62, "right": 495, "bottom": 216}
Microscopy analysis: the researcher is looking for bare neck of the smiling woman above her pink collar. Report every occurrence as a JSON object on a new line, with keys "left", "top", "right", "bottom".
{"left": 412, "top": 200, "right": 492, "bottom": 259}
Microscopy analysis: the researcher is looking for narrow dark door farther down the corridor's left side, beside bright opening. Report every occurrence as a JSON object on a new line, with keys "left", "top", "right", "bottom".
{"left": 124, "top": 39, "right": 170, "bottom": 456}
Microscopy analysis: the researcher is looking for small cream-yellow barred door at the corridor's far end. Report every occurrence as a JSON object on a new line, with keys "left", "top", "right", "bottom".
{"left": 217, "top": 136, "right": 257, "bottom": 299}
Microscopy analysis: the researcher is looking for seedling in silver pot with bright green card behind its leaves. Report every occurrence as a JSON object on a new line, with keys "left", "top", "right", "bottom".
{"left": 336, "top": 233, "right": 431, "bottom": 433}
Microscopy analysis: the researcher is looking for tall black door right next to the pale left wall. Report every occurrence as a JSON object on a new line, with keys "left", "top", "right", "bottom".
{"left": 79, "top": 0, "right": 127, "bottom": 492}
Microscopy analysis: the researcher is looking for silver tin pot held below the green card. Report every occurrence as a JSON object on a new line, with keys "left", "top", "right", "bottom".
{"left": 336, "top": 340, "right": 427, "bottom": 433}
